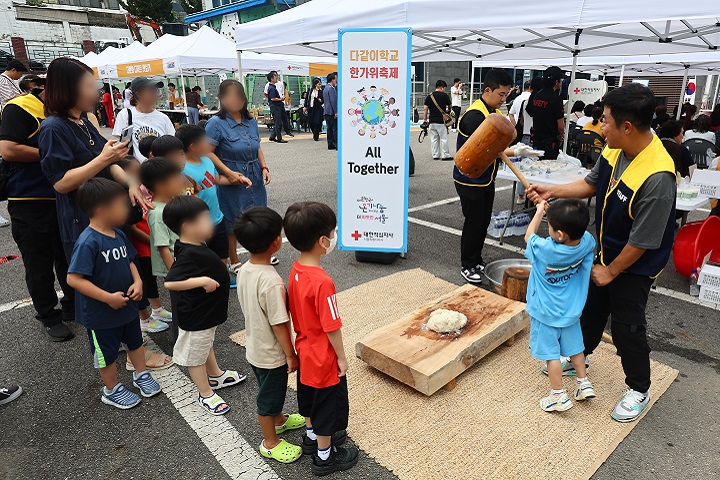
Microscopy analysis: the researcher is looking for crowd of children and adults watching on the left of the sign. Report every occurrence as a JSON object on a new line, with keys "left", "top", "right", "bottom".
{"left": 0, "top": 57, "right": 358, "bottom": 475}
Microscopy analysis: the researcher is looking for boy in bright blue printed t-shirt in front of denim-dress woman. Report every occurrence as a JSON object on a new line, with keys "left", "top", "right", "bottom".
{"left": 175, "top": 125, "right": 236, "bottom": 288}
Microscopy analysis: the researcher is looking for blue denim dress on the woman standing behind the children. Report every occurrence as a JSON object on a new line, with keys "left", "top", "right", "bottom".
{"left": 205, "top": 115, "right": 267, "bottom": 231}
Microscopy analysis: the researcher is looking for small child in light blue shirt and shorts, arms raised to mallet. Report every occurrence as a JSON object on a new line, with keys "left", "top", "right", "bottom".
{"left": 525, "top": 199, "right": 595, "bottom": 412}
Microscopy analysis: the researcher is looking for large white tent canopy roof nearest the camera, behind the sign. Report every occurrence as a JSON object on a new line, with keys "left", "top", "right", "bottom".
{"left": 235, "top": 0, "right": 720, "bottom": 61}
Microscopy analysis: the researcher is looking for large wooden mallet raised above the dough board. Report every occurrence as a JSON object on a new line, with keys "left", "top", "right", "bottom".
{"left": 455, "top": 113, "right": 530, "bottom": 193}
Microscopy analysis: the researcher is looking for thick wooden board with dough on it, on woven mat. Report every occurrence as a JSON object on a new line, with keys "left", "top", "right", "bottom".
{"left": 355, "top": 285, "right": 530, "bottom": 395}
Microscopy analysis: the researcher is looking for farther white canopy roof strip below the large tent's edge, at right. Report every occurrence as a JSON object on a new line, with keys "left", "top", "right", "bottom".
{"left": 473, "top": 51, "right": 720, "bottom": 77}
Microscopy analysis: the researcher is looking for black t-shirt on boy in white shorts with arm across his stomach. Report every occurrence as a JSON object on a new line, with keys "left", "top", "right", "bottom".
{"left": 165, "top": 240, "right": 230, "bottom": 332}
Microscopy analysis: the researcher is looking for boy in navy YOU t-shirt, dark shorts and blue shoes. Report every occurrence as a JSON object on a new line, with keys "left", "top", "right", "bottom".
{"left": 67, "top": 178, "right": 160, "bottom": 409}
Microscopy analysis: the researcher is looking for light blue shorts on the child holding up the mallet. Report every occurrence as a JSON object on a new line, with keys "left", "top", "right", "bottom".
{"left": 530, "top": 318, "right": 585, "bottom": 360}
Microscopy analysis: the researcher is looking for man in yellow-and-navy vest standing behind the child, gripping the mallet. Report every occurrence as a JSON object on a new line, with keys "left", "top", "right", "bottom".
{"left": 528, "top": 83, "right": 676, "bottom": 422}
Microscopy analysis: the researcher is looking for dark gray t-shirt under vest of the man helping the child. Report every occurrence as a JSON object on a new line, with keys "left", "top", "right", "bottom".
{"left": 585, "top": 152, "right": 677, "bottom": 250}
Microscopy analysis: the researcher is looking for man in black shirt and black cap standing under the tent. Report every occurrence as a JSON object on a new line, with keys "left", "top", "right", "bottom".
{"left": 525, "top": 67, "right": 565, "bottom": 159}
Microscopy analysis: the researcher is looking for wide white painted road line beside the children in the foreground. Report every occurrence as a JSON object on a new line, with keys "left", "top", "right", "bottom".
{"left": 146, "top": 340, "right": 280, "bottom": 480}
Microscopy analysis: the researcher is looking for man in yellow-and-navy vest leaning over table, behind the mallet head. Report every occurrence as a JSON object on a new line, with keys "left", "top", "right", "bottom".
{"left": 453, "top": 69, "right": 532, "bottom": 284}
